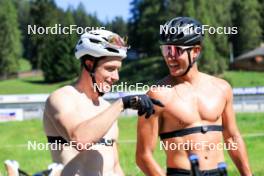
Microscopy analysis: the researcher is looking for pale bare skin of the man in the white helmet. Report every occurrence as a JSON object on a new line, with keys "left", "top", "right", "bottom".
{"left": 44, "top": 57, "right": 124, "bottom": 176}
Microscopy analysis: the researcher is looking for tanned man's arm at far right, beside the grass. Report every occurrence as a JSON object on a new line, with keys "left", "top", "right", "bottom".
{"left": 222, "top": 83, "right": 252, "bottom": 176}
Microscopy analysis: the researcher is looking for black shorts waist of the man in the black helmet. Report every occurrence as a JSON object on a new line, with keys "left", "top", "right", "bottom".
{"left": 167, "top": 168, "right": 223, "bottom": 176}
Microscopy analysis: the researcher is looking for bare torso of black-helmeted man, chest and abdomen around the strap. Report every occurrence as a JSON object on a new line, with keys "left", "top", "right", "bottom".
{"left": 156, "top": 74, "right": 226, "bottom": 170}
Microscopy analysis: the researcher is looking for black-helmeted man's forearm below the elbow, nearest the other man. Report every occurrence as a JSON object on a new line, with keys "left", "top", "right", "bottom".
{"left": 137, "top": 155, "right": 166, "bottom": 176}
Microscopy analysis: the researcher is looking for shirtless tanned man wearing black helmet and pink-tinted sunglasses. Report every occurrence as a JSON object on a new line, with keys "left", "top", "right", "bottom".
{"left": 136, "top": 17, "right": 252, "bottom": 176}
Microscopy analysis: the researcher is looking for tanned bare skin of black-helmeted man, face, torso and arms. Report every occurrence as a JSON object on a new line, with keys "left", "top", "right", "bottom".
{"left": 136, "top": 46, "right": 251, "bottom": 176}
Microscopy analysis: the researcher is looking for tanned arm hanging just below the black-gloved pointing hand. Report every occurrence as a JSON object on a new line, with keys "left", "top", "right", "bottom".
{"left": 136, "top": 92, "right": 165, "bottom": 176}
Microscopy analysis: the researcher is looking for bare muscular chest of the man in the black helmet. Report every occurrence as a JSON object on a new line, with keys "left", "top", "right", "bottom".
{"left": 162, "top": 84, "right": 226, "bottom": 129}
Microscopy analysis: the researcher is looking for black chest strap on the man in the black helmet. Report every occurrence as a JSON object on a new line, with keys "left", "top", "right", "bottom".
{"left": 160, "top": 125, "right": 223, "bottom": 139}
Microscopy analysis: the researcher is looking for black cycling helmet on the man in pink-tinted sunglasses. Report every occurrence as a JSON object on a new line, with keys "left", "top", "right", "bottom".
{"left": 160, "top": 17, "right": 203, "bottom": 46}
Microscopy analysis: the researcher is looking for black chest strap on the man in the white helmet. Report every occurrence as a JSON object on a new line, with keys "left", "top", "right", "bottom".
{"left": 47, "top": 136, "right": 115, "bottom": 146}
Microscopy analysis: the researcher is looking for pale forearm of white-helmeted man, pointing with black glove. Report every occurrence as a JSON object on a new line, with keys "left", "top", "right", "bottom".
{"left": 72, "top": 99, "right": 123, "bottom": 144}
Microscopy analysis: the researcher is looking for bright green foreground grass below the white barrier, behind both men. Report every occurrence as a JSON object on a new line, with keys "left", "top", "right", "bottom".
{"left": 0, "top": 113, "right": 264, "bottom": 176}
